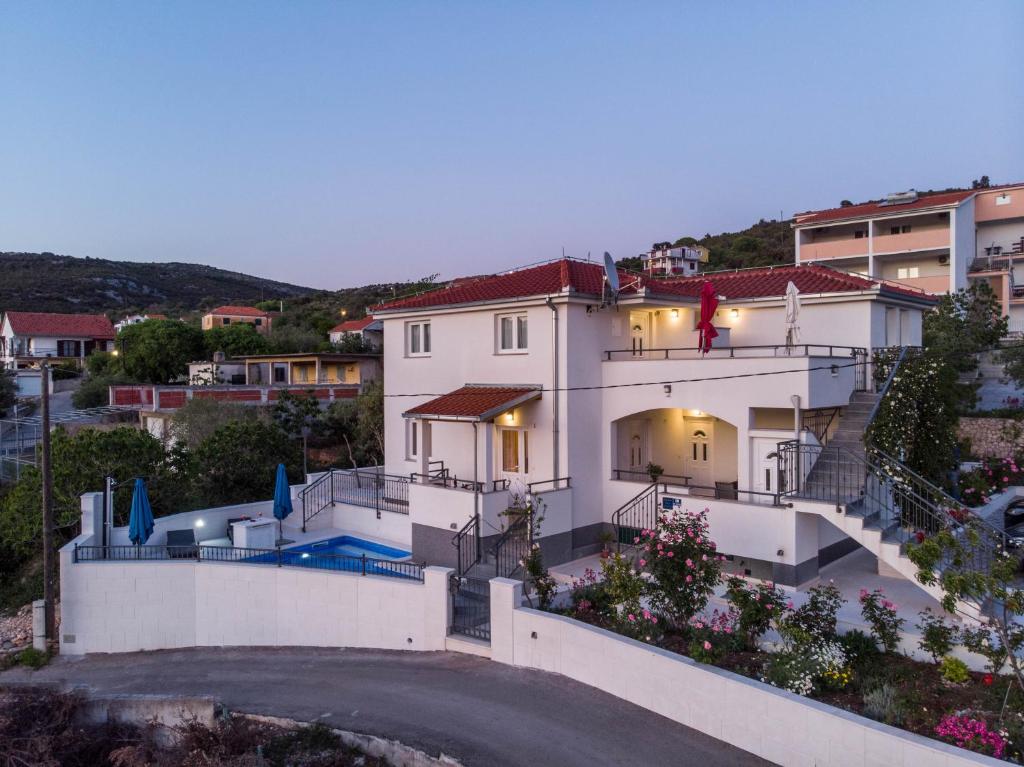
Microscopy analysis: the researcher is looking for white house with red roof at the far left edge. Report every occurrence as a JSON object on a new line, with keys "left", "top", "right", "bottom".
{"left": 0, "top": 311, "right": 116, "bottom": 370}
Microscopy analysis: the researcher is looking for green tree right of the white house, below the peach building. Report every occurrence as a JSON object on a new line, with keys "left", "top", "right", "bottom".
{"left": 922, "top": 283, "right": 1007, "bottom": 373}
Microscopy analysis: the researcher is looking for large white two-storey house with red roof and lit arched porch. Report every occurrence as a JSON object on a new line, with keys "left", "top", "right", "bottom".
{"left": 374, "top": 253, "right": 934, "bottom": 585}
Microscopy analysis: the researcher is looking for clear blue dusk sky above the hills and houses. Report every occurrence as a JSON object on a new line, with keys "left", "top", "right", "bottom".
{"left": 0, "top": 0, "right": 1024, "bottom": 288}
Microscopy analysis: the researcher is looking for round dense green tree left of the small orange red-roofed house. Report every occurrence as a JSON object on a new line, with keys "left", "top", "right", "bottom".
{"left": 117, "top": 319, "right": 206, "bottom": 384}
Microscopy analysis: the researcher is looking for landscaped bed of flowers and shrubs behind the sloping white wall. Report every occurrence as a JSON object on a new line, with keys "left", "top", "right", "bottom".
{"left": 558, "top": 512, "right": 1024, "bottom": 763}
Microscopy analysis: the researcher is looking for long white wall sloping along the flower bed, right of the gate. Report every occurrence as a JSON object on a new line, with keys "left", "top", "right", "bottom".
{"left": 490, "top": 579, "right": 1006, "bottom": 767}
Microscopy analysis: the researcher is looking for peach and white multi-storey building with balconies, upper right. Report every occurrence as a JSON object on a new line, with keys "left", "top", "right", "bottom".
{"left": 793, "top": 183, "right": 1024, "bottom": 333}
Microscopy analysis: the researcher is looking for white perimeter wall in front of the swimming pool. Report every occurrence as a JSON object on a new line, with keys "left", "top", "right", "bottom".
{"left": 60, "top": 547, "right": 450, "bottom": 655}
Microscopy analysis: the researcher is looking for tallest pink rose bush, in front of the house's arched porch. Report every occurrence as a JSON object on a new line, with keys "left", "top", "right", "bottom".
{"left": 637, "top": 509, "right": 722, "bottom": 627}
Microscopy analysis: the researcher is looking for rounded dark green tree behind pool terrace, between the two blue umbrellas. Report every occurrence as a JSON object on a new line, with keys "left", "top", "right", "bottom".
{"left": 191, "top": 420, "right": 303, "bottom": 506}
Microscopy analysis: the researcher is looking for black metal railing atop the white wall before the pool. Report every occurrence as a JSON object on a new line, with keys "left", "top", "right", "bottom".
{"left": 73, "top": 545, "right": 424, "bottom": 582}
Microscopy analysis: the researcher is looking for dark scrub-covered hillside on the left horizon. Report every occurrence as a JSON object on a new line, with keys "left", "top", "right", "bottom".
{"left": 0, "top": 253, "right": 314, "bottom": 314}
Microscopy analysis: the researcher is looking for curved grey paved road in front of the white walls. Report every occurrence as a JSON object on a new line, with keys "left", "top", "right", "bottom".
{"left": 0, "top": 648, "right": 768, "bottom": 767}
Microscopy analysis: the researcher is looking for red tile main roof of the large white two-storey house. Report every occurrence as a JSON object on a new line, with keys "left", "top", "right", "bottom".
{"left": 376, "top": 259, "right": 930, "bottom": 311}
